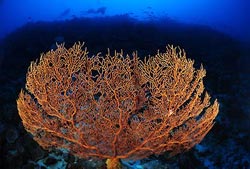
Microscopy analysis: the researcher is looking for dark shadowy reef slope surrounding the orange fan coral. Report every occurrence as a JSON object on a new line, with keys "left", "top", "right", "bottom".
{"left": 0, "top": 15, "right": 250, "bottom": 169}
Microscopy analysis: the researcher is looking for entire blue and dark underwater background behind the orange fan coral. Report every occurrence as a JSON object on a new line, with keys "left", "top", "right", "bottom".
{"left": 0, "top": 0, "right": 250, "bottom": 169}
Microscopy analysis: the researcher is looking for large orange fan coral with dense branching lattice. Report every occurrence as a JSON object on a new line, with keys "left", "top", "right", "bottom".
{"left": 17, "top": 43, "right": 219, "bottom": 168}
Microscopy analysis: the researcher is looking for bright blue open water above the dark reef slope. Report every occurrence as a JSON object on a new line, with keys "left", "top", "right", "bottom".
{"left": 0, "top": 0, "right": 250, "bottom": 41}
